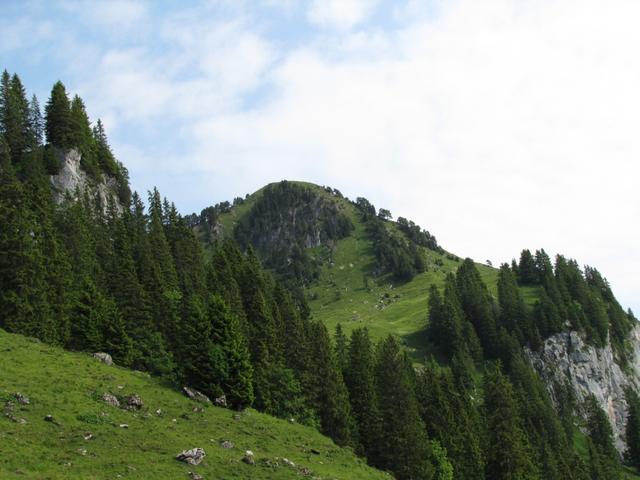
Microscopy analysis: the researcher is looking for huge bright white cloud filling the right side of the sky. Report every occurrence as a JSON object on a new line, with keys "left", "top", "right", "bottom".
{"left": 188, "top": 0, "right": 640, "bottom": 307}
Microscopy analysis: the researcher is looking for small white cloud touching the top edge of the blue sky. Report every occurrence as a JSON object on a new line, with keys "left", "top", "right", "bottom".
{"left": 307, "top": 0, "right": 378, "bottom": 30}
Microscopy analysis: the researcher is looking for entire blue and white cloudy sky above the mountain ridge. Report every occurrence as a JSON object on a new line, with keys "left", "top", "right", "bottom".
{"left": 0, "top": 0, "right": 640, "bottom": 314}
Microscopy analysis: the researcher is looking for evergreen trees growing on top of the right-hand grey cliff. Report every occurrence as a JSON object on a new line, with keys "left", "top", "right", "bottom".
{"left": 511, "top": 250, "right": 636, "bottom": 367}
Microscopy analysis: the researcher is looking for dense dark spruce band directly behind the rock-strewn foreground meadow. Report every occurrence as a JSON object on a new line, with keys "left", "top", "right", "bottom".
{"left": 0, "top": 72, "right": 640, "bottom": 480}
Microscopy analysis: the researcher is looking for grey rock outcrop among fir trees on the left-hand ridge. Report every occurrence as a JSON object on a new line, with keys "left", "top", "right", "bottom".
{"left": 51, "top": 148, "right": 123, "bottom": 213}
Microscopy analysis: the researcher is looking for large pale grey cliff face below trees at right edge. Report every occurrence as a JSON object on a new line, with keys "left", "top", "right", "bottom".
{"left": 526, "top": 325, "right": 640, "bottom": 453}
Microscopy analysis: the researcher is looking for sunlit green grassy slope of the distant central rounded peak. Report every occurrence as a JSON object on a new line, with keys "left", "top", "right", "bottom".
{"left": 210, "top": 182, "right": 500, "bottom": 360}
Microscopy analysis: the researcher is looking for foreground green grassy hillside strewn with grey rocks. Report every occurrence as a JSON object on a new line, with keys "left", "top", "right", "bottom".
{"left": 0, "top": 330, "right": 390, "bottom": 479}
